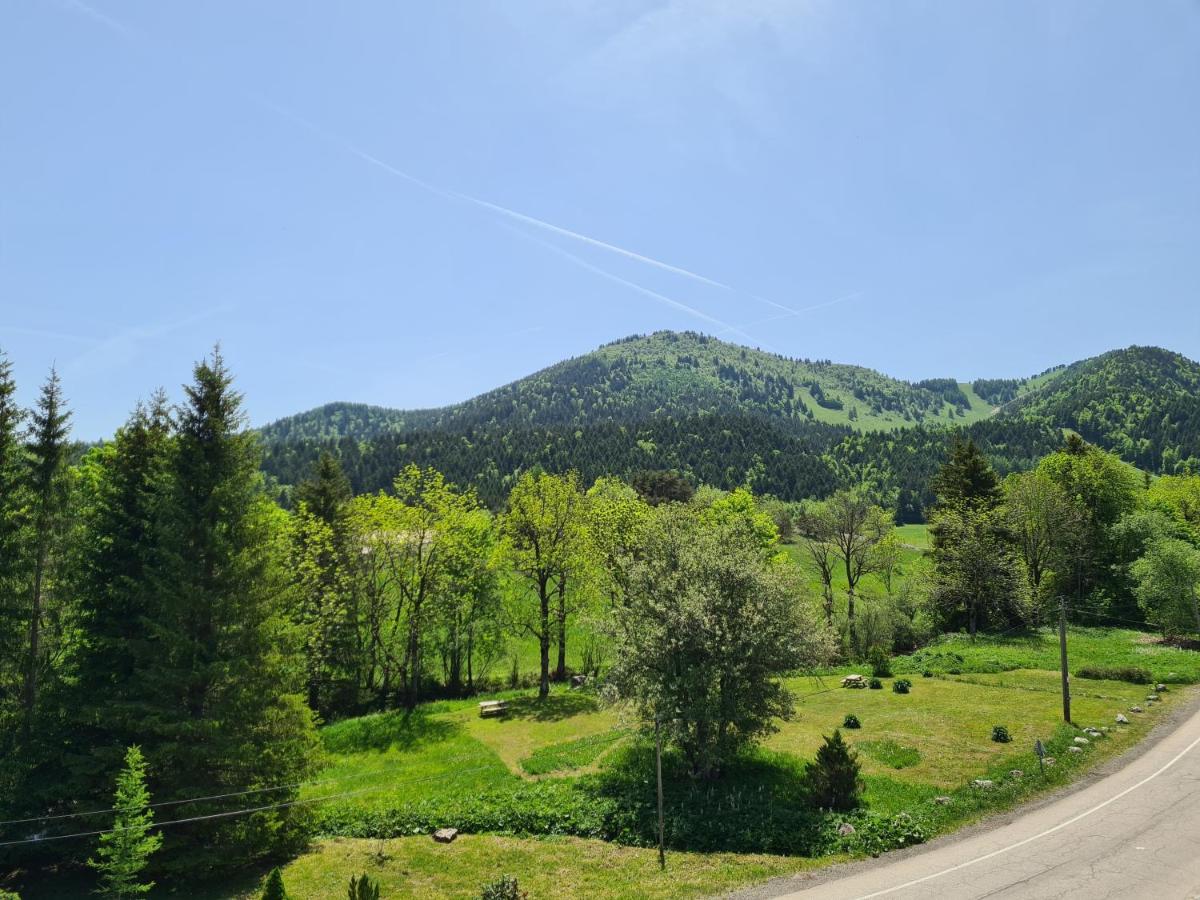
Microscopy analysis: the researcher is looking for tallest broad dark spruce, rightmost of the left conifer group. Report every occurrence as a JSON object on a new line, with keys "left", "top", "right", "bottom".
{"left": 137, "top": 350, "right": 317, "bottom": 871}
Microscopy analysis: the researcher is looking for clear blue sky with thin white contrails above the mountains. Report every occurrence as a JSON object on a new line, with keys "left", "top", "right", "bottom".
{"left": 0, "top": 0, "right": 1200, "bottom": 438}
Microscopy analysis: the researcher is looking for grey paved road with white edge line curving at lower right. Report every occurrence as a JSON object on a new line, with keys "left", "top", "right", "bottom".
{"left": 748, "top": 704, "right": 1200, "bottom": 900}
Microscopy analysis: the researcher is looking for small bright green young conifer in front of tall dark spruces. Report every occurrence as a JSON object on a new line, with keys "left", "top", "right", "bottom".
{"left": 88, "top": 745, "right": 162, "bottom": 900}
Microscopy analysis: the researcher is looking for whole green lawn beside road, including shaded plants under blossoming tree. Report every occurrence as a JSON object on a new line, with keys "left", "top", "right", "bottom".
{"left": 225, "top": 629, "right": 1200, "bottom": 899}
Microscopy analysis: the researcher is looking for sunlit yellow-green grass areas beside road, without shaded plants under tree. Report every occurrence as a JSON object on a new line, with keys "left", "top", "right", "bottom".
{"left": 218, "top": 629, "right": 1200, "bottom": 899}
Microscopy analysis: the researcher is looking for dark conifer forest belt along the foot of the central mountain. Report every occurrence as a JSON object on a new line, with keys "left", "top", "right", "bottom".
{"left": 263, "top": 415, "right": 1061, "bottom": 522}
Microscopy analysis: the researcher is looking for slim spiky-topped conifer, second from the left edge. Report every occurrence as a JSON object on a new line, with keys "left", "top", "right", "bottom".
{"left": 22, "top": 368, "right": 71, "bottom": 734}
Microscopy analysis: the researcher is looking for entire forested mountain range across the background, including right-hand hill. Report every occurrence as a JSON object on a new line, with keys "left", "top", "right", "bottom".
{"left": 262, "top": 331, "right": 1200, "bottom": 521}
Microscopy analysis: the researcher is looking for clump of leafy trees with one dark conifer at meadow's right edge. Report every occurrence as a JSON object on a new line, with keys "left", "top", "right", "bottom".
{"left": 929, "top": 434, "right": 1200, "bottom": 638}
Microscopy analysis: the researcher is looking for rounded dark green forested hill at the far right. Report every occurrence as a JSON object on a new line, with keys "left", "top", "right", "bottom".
{"left": 1002, "top": 347, "right": 1200, "bottom": 474}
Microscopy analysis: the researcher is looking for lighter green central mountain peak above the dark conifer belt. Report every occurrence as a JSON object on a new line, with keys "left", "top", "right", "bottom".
{"left": 263, "top": 331, "right": 991, "bottom": 440}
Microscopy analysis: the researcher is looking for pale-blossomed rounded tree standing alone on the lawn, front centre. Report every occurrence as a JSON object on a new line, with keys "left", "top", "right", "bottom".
{"left": 610, "top": 504, "right": 830, "bottom": 778}
